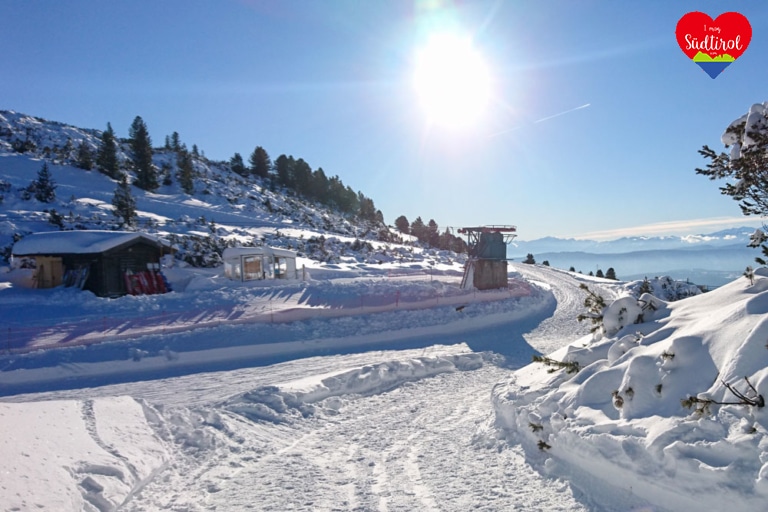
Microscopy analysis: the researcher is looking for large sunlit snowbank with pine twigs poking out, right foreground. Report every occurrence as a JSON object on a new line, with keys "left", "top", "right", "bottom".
{"left": 492, "top": 269, "right": 768, "bottom": 512}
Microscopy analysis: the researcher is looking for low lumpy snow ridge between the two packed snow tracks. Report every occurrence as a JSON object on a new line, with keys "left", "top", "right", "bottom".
{"left": 224, "top": 353, "right": 483, "bottom": 423}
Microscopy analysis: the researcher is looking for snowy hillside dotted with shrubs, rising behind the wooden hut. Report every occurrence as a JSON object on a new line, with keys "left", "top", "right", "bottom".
{"left": 0, "top": 111, "right": 404, "bottom": 265}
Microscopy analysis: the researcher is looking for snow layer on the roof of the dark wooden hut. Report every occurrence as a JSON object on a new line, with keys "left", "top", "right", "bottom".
{"left": 12, "top": 230, "right": 168, "bottom": 256}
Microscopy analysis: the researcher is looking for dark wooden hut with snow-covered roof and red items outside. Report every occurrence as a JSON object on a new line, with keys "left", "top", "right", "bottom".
{"left": 12, "top": 231, "right": 172, "bottom": 297}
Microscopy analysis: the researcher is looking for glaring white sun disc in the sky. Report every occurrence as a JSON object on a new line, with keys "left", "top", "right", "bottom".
{"left": 413, "top": 34, "right": 491, "bottom": 128}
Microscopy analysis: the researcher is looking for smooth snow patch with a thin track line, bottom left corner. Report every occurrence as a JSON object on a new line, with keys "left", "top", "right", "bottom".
{"left": 0, "top": 397, "right": 170, "bottom": 510}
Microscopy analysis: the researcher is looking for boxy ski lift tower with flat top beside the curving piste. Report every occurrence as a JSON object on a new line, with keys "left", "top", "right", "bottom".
{"left": 459, "top": 226, "right": 517, "bottom": 290}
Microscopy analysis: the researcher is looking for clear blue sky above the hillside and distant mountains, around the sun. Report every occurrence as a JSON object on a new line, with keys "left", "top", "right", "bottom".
{"left": 0, "top": 0, "right": 768, "bottom": 239}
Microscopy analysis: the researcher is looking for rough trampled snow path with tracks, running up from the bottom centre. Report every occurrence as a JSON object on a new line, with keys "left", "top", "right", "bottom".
{"left": 124, "top": 364, "right": 584, "bottom": 512}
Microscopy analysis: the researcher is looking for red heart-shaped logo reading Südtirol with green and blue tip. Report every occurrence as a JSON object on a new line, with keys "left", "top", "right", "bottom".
{"left": 675, "top": 11, "right": 752, "bottom": 78}
